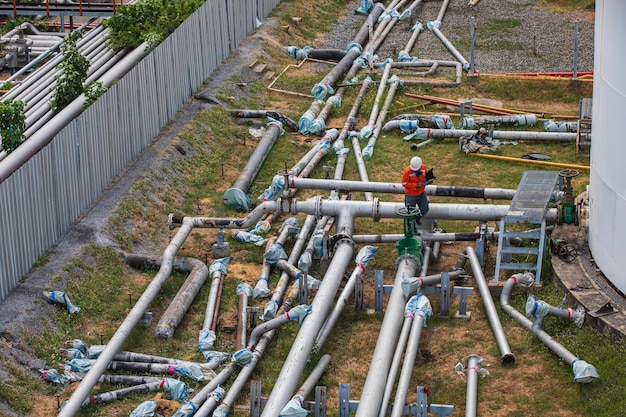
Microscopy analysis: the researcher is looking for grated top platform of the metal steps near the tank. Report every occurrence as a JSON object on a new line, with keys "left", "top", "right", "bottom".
{"left": 506, "top": 171, "right": 559, "bottom": 222}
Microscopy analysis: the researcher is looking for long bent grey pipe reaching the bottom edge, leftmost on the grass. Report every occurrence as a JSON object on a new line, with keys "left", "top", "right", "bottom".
{"left": 58, "top": 218, "right": 193, "bottom": 417}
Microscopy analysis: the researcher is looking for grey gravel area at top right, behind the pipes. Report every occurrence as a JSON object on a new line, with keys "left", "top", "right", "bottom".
{"left": 314, "top": 0, "right": 594, "bottom": 73}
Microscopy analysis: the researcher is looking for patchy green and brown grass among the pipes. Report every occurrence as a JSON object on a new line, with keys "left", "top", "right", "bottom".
{"left": 12, "top": 0, "right": 626, "bottom": 417}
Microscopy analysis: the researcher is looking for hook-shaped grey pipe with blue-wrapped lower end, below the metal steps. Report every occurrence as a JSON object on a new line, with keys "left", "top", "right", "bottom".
{"left": 500, "top": 273, "right": 599, "bottom": 383}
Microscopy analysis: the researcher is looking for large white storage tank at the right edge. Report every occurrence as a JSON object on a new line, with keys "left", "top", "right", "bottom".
{"left": 589, "top": 0, "right": 626, "bottom": 293}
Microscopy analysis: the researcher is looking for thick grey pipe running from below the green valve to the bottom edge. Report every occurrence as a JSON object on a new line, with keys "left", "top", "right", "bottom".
{"left": 355, "top": 255, "right": 420, "bottom": 417}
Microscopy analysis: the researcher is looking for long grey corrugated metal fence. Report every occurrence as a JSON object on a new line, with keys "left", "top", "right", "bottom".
{"left": 0, "top": 0, "right": 280, "bottom": 300}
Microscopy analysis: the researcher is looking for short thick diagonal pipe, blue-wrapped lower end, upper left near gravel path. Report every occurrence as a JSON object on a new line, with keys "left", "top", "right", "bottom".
{"left": 224, "top": 123, "right": 282, "bottom": 211}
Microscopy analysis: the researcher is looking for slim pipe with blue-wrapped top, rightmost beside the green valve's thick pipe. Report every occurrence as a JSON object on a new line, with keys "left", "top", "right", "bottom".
{"left": 391, "top": 294, "right": 432, "bottom": 417}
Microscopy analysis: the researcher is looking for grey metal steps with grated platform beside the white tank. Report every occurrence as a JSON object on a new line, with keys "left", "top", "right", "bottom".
{"left": 494, "top": 171, "right": 559, "bottom": 284}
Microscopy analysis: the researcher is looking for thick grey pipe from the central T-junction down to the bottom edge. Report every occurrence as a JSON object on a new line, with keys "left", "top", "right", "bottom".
{"left": 262, "top": 237, "right": 355, "bottom": 417}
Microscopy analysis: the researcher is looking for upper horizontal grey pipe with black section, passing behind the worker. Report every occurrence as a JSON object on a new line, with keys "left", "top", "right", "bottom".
{"left": 287, "top": 176, "right": 515, "bottom": 200}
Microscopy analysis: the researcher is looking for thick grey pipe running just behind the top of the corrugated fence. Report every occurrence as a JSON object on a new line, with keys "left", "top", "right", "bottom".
{"left": 0, "top": 43, "right": 150, "bottom": 182}
